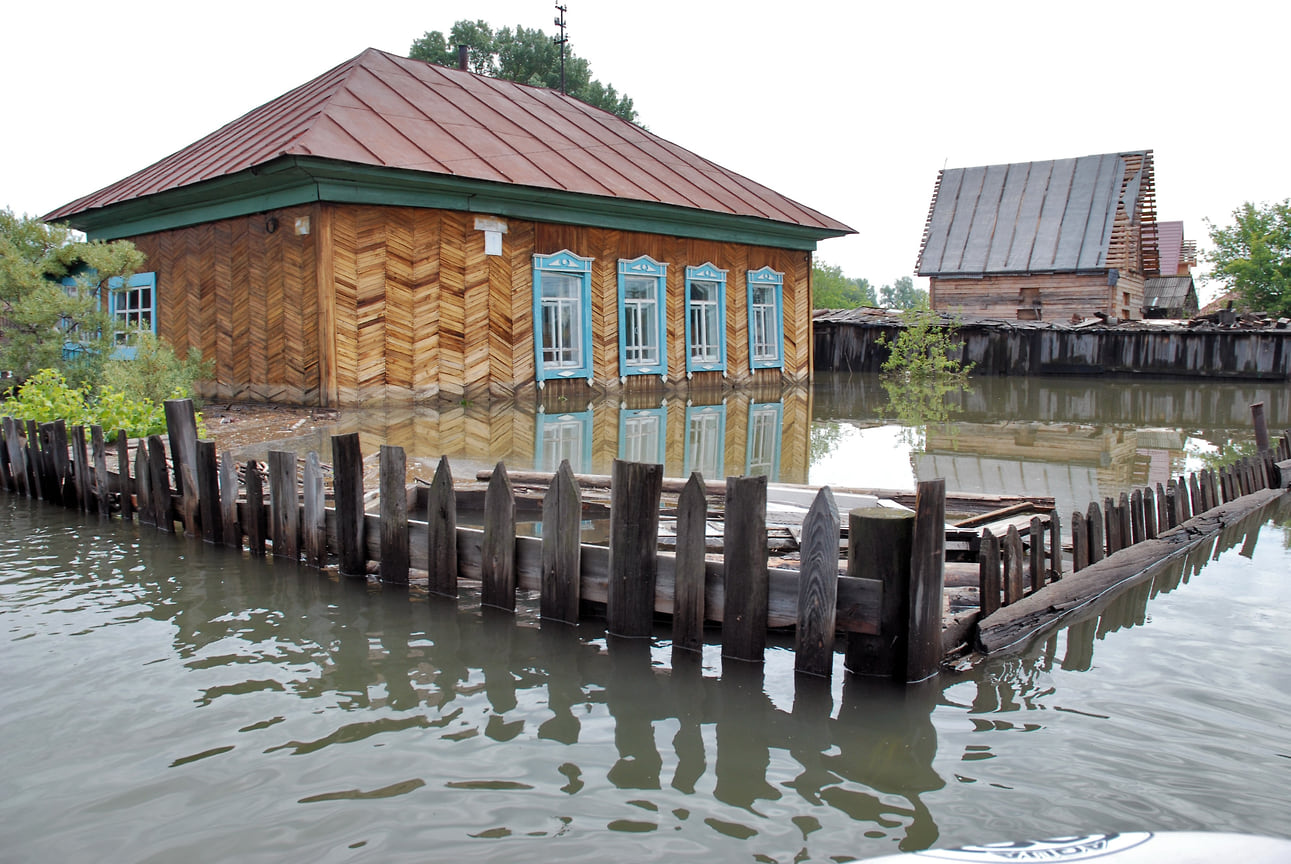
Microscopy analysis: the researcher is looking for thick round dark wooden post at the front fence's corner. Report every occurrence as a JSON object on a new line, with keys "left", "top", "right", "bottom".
{"left": 843, "top": 508, "right": 914, "bottom": 678}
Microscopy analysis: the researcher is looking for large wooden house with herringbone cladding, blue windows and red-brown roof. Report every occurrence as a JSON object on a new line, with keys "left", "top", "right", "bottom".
{"left": 45, "top": 49, "right": 852, "bottom": 406}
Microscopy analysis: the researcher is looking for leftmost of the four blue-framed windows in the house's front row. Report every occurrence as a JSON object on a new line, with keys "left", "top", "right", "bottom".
{"left": 533, "top": 249, "right": 593, "bottom": 386}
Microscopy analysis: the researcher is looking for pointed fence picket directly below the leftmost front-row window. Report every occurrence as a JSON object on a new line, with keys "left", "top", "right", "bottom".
{"left": 540, "top": 458, "right": 582, "bottom": 624}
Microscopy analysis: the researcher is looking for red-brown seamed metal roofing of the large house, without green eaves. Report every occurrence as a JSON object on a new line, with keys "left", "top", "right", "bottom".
{"left": 45, "top": 48, "right": 853, "bottom": 234}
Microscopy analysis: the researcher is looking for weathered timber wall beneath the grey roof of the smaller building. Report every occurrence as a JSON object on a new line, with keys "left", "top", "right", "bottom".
{"left": 928, "top": 273, "right": 1143, "bottom": 322}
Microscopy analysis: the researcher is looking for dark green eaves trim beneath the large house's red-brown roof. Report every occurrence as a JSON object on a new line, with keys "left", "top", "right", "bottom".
{"left": 68, "top": 156, "right": 847, "bottom": 252}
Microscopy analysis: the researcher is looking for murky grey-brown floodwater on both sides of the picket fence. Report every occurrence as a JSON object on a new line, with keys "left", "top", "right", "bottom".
{"left": 0, "top": 371, "right": 1291, "bottom": 863}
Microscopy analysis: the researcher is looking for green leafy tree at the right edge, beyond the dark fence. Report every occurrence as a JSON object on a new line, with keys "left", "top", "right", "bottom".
{"left": 1206, "top": 199, "right": 1291, "bottom": 315}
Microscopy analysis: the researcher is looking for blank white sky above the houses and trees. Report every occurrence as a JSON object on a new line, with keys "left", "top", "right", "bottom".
{"left": 0, "top": 0, "right": 1291, "bottom": 303}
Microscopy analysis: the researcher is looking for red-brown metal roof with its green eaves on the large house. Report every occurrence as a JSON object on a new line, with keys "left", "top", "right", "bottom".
{"left": 45, "top": 48, "right": 853, "bottom": 249}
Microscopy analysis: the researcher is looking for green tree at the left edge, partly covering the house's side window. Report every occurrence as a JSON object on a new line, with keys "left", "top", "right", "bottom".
{"left": 0, "top": 209, "right": 143, "bottom": 386}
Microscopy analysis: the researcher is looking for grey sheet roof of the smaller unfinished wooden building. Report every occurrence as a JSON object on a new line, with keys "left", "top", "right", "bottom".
{"left": 919, "top": 154, "right": 1143, "bottom": 276}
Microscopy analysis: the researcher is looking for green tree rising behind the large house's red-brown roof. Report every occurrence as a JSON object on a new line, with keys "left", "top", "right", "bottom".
{"left": 408, "top": 19, "right": 636, "bottom": 123}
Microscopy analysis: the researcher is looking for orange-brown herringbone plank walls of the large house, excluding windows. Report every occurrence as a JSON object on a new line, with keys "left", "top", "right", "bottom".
{"left": 123, "top": 204, "right": 813, "bottom": 406}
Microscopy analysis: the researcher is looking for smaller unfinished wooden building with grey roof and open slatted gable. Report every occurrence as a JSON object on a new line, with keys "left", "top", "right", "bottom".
{"left": 918, "top": 150, "right": 1159, "bottom": 322}
